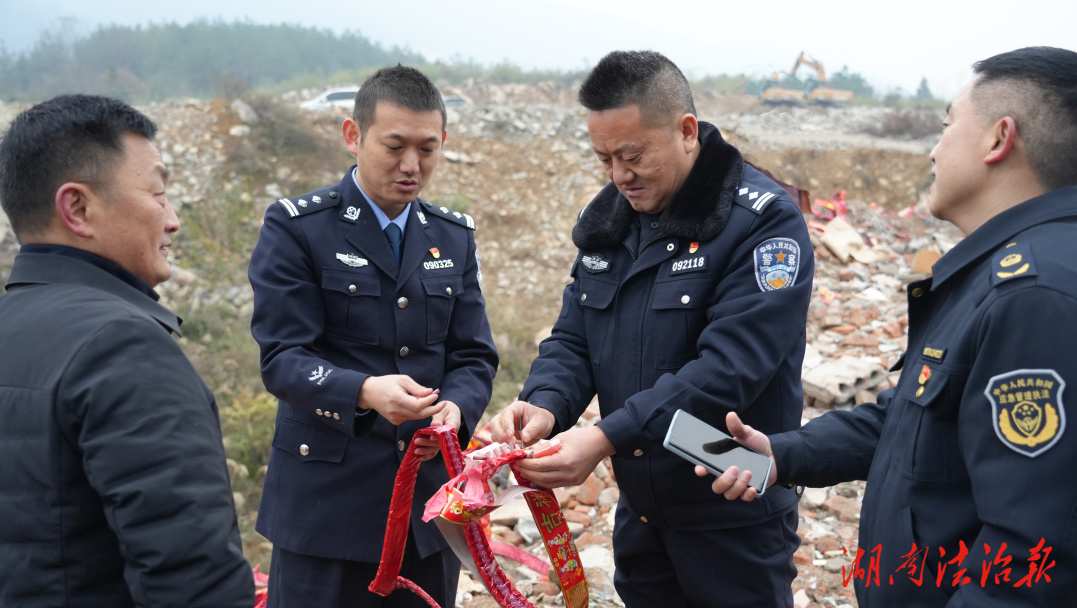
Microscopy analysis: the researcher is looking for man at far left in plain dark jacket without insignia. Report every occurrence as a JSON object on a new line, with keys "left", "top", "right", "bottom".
{"left": 0, "top": 96, "right": 254, "bottom": 608}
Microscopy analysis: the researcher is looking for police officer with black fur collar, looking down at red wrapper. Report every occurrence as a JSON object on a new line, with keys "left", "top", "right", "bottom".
{"left": 492, "top": 52, "right": 814, "bottom": 607}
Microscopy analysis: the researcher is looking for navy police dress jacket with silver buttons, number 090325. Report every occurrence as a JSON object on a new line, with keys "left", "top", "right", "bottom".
{"left": 250, "top": 167, "right": 498, "bottom": 562}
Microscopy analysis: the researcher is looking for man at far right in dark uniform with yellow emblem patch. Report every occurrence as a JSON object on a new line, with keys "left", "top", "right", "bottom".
{"left": 697, "top": 47, "right": 1077, "bottom": 608}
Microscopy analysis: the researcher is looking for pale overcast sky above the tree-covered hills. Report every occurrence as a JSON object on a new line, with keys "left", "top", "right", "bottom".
{"left": 0, "top": 0, "right": 1077, "bottom": 98}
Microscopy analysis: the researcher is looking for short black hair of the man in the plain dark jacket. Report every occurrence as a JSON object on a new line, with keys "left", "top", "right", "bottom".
{"left": 0, "top": 95, "right": 157, "bottom": 240}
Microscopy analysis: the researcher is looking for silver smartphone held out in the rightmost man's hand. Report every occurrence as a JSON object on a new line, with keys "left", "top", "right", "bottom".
{"left": 662, "top": 410, "right": 771, "bottom": 496}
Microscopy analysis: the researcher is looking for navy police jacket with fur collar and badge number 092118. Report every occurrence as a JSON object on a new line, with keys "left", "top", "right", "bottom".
{"left": 520, "top": 123, "right": 814, "bottom": 529}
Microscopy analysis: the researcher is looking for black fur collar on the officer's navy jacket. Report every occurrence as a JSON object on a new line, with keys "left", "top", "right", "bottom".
{"left": 572, "top": 121, "right": 744, "bottom": 250}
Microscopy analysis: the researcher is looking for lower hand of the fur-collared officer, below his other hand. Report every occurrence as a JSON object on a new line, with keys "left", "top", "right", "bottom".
{"left": 506, "top": 426, "right": 615, "bottom": 489}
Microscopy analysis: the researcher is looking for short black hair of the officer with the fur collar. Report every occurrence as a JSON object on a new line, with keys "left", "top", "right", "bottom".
{"left": 576, "top": 51, "right": 696, "bottom": 126}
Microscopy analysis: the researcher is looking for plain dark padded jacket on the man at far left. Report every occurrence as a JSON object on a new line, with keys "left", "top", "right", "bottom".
{"left": 0, "top": 247, "right": 254, "bottom": 608}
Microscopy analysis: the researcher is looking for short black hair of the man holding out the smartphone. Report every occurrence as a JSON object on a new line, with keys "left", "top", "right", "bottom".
{"left": 971, "top": 46, "right": 1077, "bottom": 190}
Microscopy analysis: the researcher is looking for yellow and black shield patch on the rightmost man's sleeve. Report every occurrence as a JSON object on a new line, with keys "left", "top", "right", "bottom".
{"left": 983, "top": 369, "right": 1066, "bottom": 458}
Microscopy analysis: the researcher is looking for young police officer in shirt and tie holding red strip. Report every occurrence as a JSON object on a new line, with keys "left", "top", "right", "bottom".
{"left": 250, "top": 66, "right": 498, "bottom": 608}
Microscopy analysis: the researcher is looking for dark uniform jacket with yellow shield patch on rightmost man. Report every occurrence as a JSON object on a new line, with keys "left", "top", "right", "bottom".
{"left": 771, "top": 186, "right": 1077, "bottom": 608}
